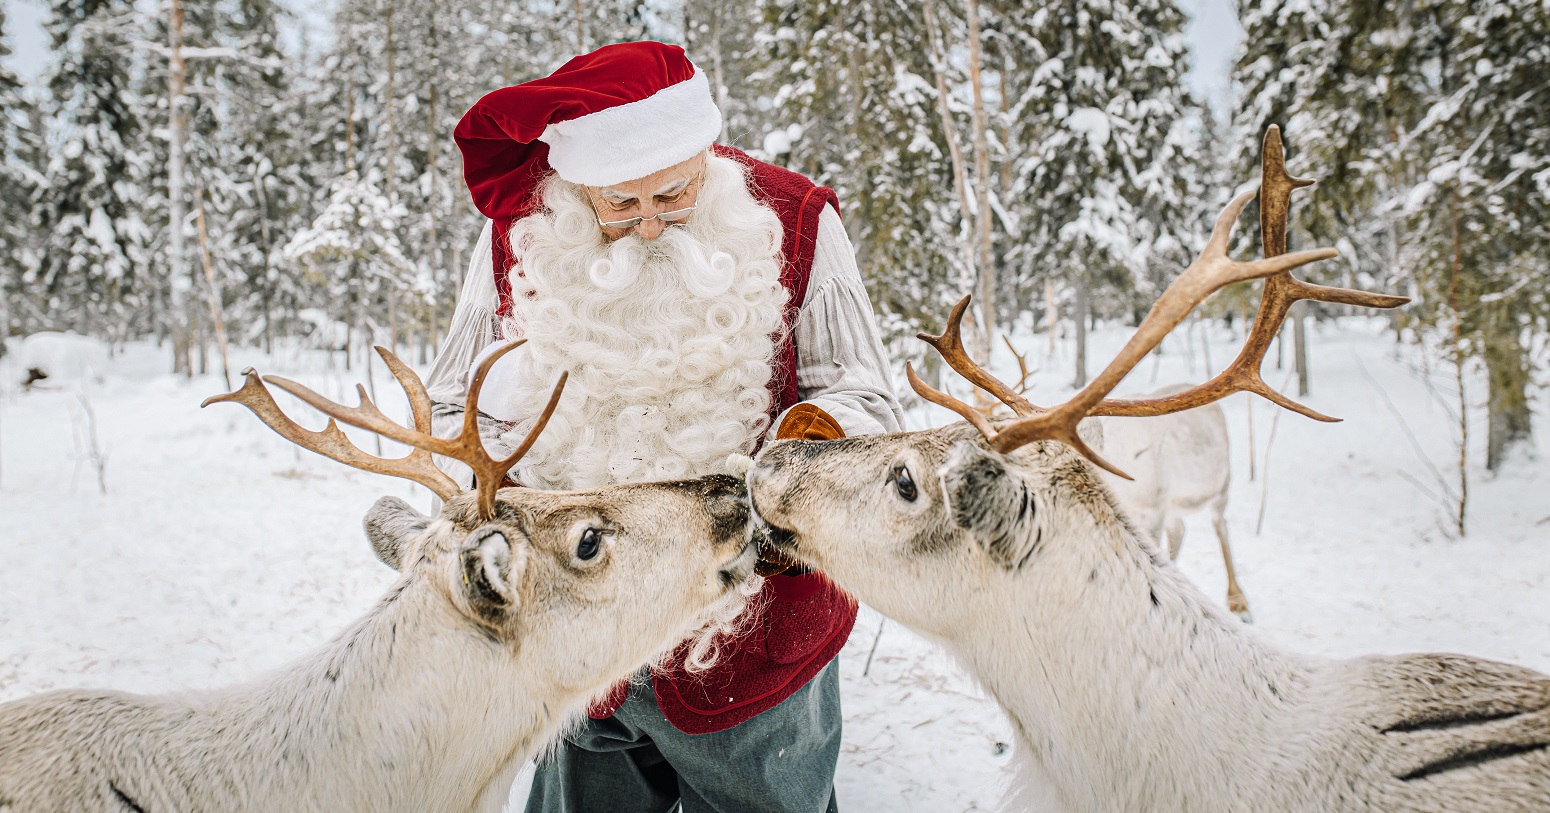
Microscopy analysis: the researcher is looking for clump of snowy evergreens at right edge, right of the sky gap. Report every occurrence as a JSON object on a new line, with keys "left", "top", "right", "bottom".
{"left": 1234, "top": 0, "right": 1550, "bottom": 480}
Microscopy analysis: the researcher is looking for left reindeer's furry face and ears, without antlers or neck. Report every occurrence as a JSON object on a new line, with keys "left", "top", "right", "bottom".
{"left": 366, "top": 475, "right": 756, "bottom": 691}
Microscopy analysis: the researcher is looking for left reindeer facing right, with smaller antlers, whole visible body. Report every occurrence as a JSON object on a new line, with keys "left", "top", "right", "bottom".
{"left": 0, "top": 342, "right": 756, "bottom": 813}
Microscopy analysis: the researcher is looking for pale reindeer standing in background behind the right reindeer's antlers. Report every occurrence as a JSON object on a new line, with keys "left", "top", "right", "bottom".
{"left": 1102, "top": 390, "right": 1254, "bottom": 621}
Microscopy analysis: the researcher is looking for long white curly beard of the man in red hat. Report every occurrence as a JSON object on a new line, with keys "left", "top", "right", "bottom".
{"left": 481, "top": 156, "right": 787, "bottom": 489}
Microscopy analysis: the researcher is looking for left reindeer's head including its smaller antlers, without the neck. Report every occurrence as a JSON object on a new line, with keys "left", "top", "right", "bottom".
{"left": 206, "top": 342, "right": 756, "bottom": 692}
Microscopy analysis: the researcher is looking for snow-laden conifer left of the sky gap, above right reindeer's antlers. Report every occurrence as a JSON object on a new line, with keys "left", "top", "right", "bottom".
{"left": 994, "top": 0, "right": 1206, "bottom": 384}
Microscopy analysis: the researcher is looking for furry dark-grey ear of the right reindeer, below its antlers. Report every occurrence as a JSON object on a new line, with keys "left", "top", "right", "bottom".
{"left": 941, "top": 443, "right": 1043, "bottom": 570}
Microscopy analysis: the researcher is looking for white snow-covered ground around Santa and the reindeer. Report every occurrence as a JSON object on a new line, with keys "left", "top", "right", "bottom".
{"left": 0, "top": 321, "right": 1550, "bottom": 811}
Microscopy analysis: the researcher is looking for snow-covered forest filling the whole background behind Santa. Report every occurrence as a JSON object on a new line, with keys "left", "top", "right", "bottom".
{"left": 0, "top": 0, "right": 1550, "bottom": 483}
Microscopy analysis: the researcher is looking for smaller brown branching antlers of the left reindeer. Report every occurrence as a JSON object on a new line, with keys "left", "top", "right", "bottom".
{"left": 200, "top": 339, "right": 567, "bottom": 519}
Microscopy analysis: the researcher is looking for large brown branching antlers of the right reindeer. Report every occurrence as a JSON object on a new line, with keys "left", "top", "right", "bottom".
{"left": 907, "top": 125, "right": 1409, "bottom": 480}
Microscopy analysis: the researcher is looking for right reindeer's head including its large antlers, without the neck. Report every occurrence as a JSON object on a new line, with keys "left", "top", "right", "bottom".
{"left": 749, "top": 132, "right": 1407, "bottom": 630}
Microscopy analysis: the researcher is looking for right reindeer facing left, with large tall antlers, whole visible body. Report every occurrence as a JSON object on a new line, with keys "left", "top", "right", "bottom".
{"left": 749, "top": 130, "right": 1550, "bottom": 813}
